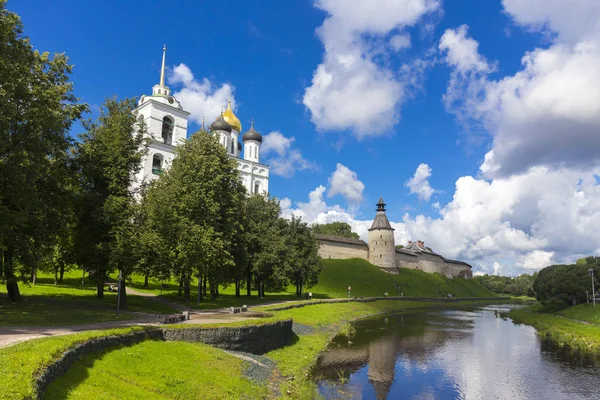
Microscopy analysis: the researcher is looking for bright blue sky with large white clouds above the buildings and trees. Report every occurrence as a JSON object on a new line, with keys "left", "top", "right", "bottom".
{"left": 8, "top": 0, "right": 600, "bottom": 275}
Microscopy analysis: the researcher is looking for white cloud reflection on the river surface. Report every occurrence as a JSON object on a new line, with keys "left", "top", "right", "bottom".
{"left": 432, "top": 312, "right": 594, "bottom": 400}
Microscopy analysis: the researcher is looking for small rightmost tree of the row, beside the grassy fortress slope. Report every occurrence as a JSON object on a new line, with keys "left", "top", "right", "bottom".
{"left": 282, "top": 216, "right": 323, "bottom": 296}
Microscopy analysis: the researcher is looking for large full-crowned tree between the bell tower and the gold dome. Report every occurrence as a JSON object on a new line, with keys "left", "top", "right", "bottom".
{"left": 139, "top": 132, "right": 245, "bottom": 302}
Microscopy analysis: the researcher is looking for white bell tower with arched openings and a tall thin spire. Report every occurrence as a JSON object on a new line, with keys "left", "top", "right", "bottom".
{"left": 134, "top": 45, "right": 190, "bottom": 187}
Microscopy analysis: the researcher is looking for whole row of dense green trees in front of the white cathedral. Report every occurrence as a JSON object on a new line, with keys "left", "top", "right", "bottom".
{"left": 0, "top": 0, "right": 322, "bottom": 305}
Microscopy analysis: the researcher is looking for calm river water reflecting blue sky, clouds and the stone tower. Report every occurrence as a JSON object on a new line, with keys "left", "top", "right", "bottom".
{"left": 314, "top": 305, "right": 600, "bottom": 400}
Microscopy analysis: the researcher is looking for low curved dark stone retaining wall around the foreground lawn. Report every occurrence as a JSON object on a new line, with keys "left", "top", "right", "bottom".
{"left": 35, "top": 319, "right": 294, "bottom": 399}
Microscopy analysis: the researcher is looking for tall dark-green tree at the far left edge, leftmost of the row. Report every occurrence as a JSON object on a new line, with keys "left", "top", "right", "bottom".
{"left": 0, "top": 0, "right": 86, "bottom": 301}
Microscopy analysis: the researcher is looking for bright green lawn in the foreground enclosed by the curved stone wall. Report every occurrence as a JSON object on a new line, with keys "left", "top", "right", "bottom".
{"left": 44, "top": 341, "right": 268, "bottom": 400}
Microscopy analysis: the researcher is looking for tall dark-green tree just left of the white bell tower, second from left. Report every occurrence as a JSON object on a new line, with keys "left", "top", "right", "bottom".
{"left": 74, "top": 99, "right": 147, "bottom": 308}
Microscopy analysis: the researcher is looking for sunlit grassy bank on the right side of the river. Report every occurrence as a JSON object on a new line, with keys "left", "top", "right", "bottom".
{"left": 508, "top": 303, "right": 600, "bottom": 356}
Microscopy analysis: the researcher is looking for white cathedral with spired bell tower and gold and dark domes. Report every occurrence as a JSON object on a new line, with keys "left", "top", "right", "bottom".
{"left": 134, "top": 47, "right": 269, "bottom": 194}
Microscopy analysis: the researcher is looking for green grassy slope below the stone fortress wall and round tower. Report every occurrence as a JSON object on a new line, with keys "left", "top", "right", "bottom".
{"left": 311, "top": 259, "right": 495, "bottom": 298}
